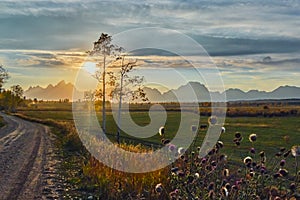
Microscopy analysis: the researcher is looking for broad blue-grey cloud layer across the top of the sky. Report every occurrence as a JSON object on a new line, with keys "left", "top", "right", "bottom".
{"left": 0, "top": 0, "right": 300, "bottom": 53}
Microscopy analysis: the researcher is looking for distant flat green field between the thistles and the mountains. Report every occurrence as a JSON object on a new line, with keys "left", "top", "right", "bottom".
{"left": 20, "top": 100, "right": 300, "bottom": 164}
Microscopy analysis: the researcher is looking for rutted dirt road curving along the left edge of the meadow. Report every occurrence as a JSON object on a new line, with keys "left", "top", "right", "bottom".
{"left": 0, "top": 112, "right": 63, "bottom": 200}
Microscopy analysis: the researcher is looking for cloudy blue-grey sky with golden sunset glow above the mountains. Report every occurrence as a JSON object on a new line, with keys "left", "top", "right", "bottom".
{"left": 0, "top": 0, "right": 300, "bottom": 91}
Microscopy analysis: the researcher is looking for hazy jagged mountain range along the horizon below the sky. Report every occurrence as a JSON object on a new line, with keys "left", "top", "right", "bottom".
{"left": 24, "top": 81, "right": 300, "bottom": 102}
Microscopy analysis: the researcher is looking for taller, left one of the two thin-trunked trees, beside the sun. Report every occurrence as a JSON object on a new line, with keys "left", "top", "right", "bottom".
{"left": 89, "top": 33, "right": 122, "bottom": 133}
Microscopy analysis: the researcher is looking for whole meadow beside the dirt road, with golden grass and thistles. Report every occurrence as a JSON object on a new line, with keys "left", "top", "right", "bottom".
{"left": 18, "top": 102, "right": 300, "bottom": 199}
